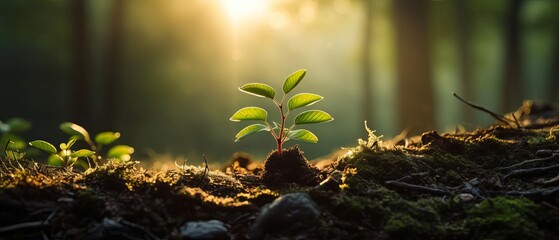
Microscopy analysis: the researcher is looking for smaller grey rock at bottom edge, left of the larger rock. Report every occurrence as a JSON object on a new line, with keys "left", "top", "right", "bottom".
{"left": 181, "top": 220, "right": 231, "bottom": 240}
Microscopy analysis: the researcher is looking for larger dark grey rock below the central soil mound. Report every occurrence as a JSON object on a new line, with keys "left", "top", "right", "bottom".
{"left": 250, "top": 193, "right": 320, "bottom": 240}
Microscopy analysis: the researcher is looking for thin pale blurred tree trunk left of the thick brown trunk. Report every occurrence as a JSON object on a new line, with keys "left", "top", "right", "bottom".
{"left": 361, "top": 0, "right": 373, "bottom": 124}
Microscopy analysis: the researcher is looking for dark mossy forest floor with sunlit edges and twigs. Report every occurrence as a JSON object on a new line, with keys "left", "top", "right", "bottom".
{"left": 0, "top": 113, "right": 559, "bottom": 239}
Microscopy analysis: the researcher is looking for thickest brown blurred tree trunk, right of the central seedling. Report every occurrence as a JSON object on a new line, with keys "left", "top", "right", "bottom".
{"left": 394, "top": 0, "right": 435, "bottom": 135}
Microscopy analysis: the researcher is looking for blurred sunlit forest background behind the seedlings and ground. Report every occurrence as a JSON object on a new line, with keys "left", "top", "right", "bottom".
{"left": 0, "top": 0, "right": 559, "bottom": 167}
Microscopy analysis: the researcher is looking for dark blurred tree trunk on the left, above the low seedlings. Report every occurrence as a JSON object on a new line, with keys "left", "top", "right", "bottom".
{"left": 70, "top": 0, "right": 91, "bottom": 125}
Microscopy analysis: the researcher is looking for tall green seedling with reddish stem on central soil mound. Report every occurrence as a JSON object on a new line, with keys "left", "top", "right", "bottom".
{"left": 230, "top": 69, "right": 334, "bottom": 155}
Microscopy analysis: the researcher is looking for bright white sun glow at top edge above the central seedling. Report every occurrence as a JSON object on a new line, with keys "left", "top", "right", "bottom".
{"left": 221, "top": 0, "right": 269, "bottom": 21}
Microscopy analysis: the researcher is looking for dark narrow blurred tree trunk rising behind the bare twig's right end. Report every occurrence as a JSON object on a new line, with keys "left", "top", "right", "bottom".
{"left": 503, "top": 0, "right": 530, "bottom": 112}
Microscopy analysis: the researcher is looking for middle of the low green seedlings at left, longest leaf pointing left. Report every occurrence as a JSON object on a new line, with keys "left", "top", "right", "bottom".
{"left": 29, "top": 139, "right": 95, "bottom": 167}
